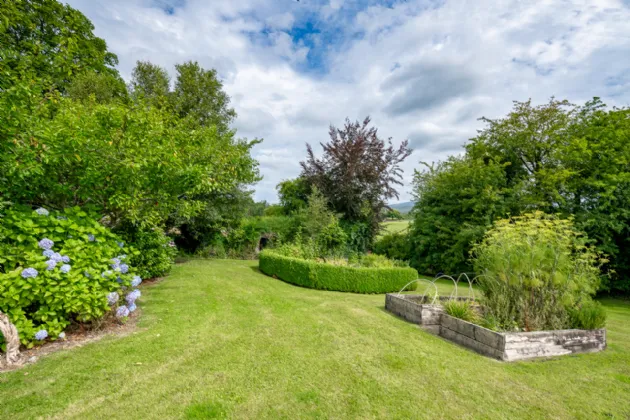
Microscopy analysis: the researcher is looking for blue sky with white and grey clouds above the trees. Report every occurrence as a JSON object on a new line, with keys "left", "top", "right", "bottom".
{"left": 67, "top": 0, "right": 630, "bottom": 202}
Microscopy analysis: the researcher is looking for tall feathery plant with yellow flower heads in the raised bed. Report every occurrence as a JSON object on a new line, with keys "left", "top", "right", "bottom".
{"left": 472, "top": 212, "right": 607, "bottom": 331}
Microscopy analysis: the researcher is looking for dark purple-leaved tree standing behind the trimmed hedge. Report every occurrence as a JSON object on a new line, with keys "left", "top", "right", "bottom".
{"left": 301, "top": 117, "right": 411, "bottom": 250}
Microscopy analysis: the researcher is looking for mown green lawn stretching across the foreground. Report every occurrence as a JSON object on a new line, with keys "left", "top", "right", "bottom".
{"left": 0, "top": 261, "right": 630, "bottom": 419}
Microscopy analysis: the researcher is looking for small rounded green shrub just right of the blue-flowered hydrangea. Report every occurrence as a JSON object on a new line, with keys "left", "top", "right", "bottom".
{"left": 120, "top": 226, "right": 177, "bottom": 279}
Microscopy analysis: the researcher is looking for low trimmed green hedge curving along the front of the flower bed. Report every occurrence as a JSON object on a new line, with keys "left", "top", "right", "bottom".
{"left": 259, "top": 251, "right": 418, "bottom": 293}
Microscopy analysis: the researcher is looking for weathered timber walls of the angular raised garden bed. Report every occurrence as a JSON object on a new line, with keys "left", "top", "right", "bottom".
{"left": 385, "top": 293, "right": 606, "bottom": 362}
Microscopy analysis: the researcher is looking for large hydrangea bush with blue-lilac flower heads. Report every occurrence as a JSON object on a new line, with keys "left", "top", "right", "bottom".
{"left": 0, "top": 207, "right": 142, "bottom": 347}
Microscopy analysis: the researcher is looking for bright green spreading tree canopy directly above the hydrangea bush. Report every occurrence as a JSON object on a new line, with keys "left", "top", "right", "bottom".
{"left": 0, "top": 93, "right": 257, "bottom": 226}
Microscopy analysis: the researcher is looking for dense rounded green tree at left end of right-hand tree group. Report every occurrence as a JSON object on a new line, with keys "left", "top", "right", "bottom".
{"left": 409, "top": 157, "right": 511, "bottom": 274}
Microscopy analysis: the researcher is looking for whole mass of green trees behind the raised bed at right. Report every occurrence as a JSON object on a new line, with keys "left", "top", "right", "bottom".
{"left": 410, "top": 98, "right": 630, "bottom": 292}
